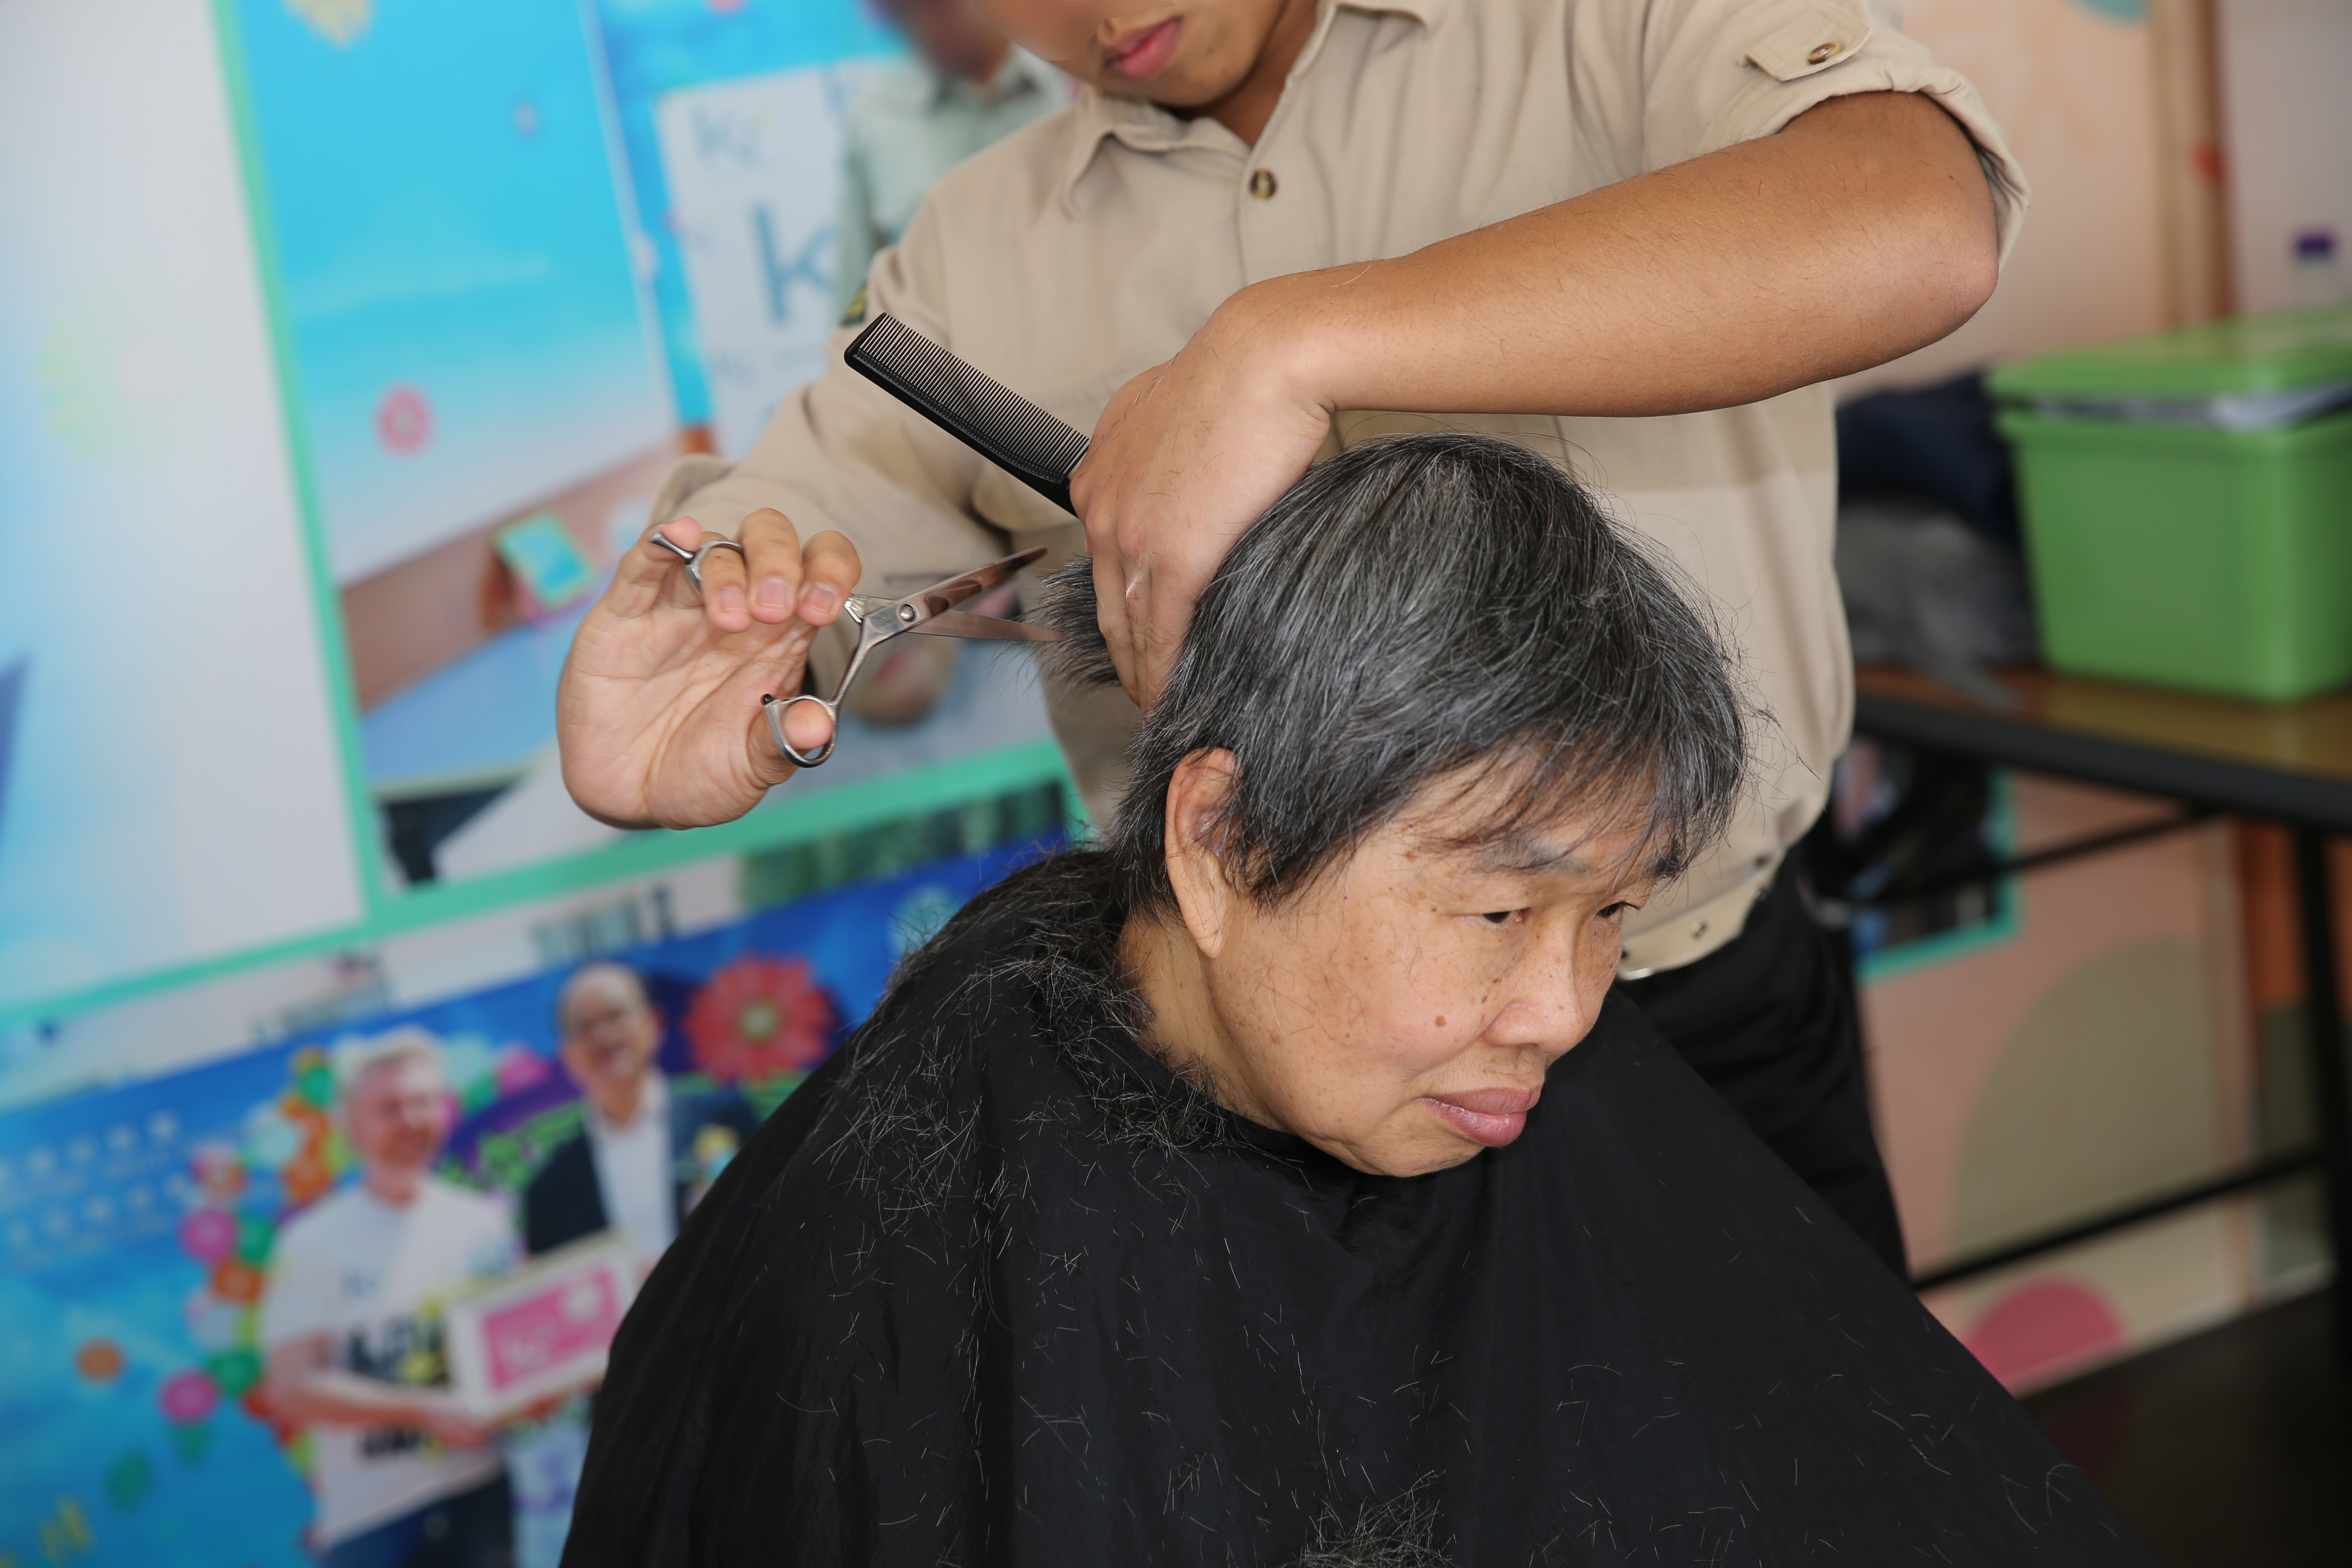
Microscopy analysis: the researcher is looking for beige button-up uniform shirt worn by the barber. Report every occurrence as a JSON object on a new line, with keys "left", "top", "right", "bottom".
{"left": 659, "top": 0, "right": 2025, "bottom": 973}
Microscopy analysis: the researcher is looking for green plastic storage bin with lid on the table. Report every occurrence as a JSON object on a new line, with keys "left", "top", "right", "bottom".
{"left": 1992, "top": 308, "right": 2352, "bottom": 703}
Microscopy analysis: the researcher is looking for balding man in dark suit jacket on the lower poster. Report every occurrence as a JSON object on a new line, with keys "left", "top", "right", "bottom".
{"left": 522, "top": 964, "right": 760, "bottom": 1267}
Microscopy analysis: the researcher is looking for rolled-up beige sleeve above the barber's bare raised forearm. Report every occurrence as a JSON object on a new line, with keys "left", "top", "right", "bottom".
{"left": 1571, "top": 0, "right": 2030, "bottom": 261}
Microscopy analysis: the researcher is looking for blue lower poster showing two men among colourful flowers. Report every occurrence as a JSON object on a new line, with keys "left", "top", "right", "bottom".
{"left": 0, "top": 827, "right": 1056, "bottom": 1568}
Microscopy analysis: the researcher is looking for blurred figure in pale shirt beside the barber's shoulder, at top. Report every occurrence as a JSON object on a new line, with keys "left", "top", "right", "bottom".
{"left": 833, "top": 0, "right": 1070, "bottom": 315}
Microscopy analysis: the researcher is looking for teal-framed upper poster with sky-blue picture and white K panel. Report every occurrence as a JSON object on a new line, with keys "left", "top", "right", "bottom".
{"left": 207, "top": 0, "right": 1047, "bottom": 903}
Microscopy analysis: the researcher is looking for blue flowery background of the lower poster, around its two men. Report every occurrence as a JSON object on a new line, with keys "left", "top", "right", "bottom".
{"left": 0, "top": 846, "right": 1028, "bottom": 1568}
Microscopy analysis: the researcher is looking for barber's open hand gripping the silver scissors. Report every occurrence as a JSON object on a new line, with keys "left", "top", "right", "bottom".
{"left": 555, "top": 508, "right": 858, "bottom": 828}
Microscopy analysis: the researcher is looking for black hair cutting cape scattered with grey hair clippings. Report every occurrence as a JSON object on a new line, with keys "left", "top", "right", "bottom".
{"left": 564, "top": 856, "right": 2155, "bottom": 1568}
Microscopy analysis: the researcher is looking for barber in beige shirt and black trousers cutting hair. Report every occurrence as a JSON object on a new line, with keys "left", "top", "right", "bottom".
{"left": 562, "top": 0, "right": 2025, "bottom": 1267}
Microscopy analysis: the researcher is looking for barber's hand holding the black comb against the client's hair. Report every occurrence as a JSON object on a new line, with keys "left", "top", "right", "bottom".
{"left": 1070, "top": 296, "right": 1331, "bottom": 708}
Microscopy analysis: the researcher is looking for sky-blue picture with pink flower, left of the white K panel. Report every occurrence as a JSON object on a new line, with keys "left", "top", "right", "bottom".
{"left": 223, "top": 0, "right": 675, "bottom": 886}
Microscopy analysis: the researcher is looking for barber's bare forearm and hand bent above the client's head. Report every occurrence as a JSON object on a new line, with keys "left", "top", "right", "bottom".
{"left": 1070, "top": 94, "right": 1997, "bottom": 703}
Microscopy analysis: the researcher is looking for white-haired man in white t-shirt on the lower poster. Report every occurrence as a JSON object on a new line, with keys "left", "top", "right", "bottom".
{"left": 261, "top": 1025, "right": 515, "bottom": 1568}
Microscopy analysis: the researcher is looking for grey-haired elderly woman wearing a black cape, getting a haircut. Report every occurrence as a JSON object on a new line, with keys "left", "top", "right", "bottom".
{"left": 567, "top": 435, "right": 2150, "bottom": 1568}
